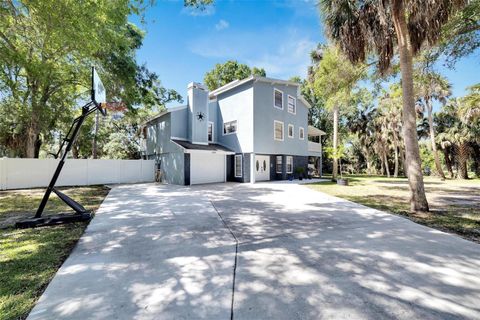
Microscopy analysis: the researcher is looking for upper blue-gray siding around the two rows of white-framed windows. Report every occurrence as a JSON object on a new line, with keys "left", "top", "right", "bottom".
{"left": 253, "top": 82, "right": 308, "bottom": 156}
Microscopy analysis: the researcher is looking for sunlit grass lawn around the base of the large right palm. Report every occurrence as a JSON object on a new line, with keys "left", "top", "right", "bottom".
{"left": 309, "top": 175, "right": 480, "bottom": 242}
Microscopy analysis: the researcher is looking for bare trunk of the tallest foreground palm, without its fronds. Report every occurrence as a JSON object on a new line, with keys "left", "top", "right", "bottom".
{"left": 392, "top": 0, "right": 429, "bottom": 212}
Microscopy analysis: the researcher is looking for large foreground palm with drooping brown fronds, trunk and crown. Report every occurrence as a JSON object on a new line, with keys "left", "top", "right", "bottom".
{"left": 320, "top": 0, "right": 467, "bottom": 211}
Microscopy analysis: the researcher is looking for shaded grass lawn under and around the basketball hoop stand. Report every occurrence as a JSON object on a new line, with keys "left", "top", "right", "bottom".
{"left": 0, "top": 186, "right": 109, "bottom": 320}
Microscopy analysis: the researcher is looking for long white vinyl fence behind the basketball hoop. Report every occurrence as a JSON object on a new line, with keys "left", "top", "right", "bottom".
{"left": 0, "top": 158, "right": 155, "bottom": 190}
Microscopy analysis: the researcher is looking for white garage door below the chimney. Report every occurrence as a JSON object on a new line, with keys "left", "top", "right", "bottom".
{"left": 190, "top": 152, "right": 225, "bottom": 184}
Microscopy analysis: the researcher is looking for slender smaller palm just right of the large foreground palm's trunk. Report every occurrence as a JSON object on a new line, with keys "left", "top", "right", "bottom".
{"left": 415, "top": 71, "right": 452, "bottom": 179}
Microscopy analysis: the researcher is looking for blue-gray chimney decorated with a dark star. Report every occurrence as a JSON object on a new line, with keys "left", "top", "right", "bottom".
{"left": 187, "top": 82, "right": 208, "bottom": 144}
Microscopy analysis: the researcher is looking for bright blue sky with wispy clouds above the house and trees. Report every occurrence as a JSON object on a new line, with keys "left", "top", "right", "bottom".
{"left": 133, "top": 0, "right": 480, "bottom": 109}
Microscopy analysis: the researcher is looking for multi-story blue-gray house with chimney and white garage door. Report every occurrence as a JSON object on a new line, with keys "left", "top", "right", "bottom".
{"left": 143, "top": 76, "right": 324, "bottom": 185}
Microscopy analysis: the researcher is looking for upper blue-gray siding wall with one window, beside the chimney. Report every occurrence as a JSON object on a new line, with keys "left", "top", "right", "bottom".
{"left": 216, "top": 81, "right": 253, "bottom": 153}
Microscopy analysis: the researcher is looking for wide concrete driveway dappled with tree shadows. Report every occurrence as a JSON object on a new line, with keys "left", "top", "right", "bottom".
{"left": 29, "top": 182, "right": 480, "bottom": 320}
